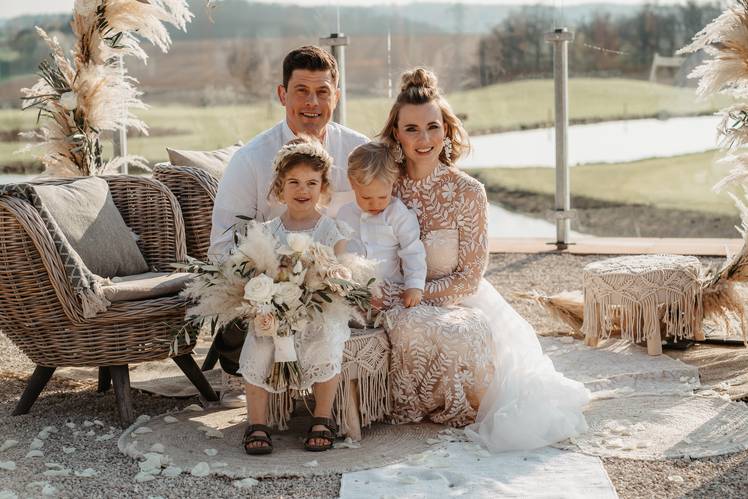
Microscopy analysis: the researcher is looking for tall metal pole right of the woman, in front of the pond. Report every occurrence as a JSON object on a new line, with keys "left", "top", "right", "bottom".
{"left": 545, "top": 28, "right": 574, "bottom": 249}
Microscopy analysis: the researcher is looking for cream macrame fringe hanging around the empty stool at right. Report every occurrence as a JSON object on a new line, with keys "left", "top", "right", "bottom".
{"left": 582, "top": 276, "right": 704, "bottom": 343}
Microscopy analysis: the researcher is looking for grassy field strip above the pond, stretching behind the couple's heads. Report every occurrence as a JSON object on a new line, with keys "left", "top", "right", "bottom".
{"left": 0, "top": 79, "right": 728, "bottom": 164}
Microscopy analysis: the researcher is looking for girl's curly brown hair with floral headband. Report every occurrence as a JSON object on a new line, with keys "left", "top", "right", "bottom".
{"left": 268, "top": 135, "right": 332, "bottom": 205}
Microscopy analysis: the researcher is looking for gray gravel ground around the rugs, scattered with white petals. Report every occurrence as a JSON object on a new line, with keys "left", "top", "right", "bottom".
{"left": 0, "top": 254, "right": 748, "bottom": 498}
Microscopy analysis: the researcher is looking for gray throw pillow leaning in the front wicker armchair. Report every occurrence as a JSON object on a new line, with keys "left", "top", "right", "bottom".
{"left": 34, "top": 177, "right": 148, "bottom": 277}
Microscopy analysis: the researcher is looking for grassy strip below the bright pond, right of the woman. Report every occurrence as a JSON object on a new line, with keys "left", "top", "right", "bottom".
{"left": 469, "top": 152, "right": 737, "bottom": 215}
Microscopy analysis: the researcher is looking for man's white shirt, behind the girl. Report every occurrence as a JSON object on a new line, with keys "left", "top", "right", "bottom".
{"left": 208, "top": 120, "right": 369, "bottom": 260}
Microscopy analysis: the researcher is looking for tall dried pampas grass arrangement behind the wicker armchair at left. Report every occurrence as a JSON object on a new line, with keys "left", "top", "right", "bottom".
{"left": 21, "top": 0, "right": 192, "bottom": 177}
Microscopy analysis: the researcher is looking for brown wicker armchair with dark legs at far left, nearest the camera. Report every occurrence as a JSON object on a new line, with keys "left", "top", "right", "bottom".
{"left": 0, "top": 176, "right": 217, "bottom": 423}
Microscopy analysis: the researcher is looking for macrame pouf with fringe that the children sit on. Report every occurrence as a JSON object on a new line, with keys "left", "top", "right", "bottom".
{"left": 268, "top": 328, "right": 391, "bottom": 441}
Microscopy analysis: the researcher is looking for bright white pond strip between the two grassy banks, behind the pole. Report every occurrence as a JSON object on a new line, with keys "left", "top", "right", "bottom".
{"left": 459, "top": 116, "right": 720, "bottom": 168}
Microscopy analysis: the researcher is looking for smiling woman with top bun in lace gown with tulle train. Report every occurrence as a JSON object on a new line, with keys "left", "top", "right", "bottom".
{"left": 380, "top": 68, "right": 590, "bottom": 451}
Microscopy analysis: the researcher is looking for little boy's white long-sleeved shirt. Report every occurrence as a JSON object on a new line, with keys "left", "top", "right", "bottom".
{"left": 336, "top": 197, "right": 426, "bottom": 290}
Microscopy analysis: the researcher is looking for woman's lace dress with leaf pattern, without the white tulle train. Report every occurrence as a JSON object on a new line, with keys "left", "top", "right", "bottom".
{"left": 385, "top": 165, "right": 494, "bottom": 426}
